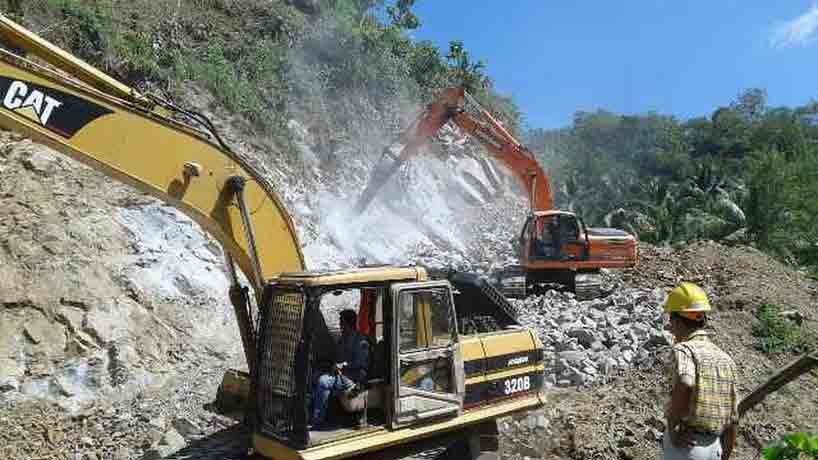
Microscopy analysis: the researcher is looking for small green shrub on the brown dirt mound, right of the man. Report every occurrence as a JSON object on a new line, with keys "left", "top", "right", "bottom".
{"left": 753, "top": 303, "right": 812, "bottom": 354}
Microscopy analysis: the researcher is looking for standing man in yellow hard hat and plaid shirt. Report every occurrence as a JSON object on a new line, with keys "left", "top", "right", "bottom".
{"left": 664, "top": 283, "right": 738, "bottom": 460}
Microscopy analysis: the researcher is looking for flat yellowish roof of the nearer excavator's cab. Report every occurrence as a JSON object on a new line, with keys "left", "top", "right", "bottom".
{"left": 276, "top": 265, "right": 428, "bottom": 286}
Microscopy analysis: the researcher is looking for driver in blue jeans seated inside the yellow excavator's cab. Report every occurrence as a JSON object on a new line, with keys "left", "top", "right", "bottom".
{"left": 311, "top": 310, "right": 369, "bottom": 429}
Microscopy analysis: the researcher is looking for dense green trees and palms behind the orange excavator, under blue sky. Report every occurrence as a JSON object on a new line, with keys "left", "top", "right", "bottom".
{"left": 529, "top": 88, "right": 818, "bottom": 272}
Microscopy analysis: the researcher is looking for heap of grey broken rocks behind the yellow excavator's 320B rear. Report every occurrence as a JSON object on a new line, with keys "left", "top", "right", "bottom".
{"left": 512, "top": 289, "right": 671, "bottom": 386}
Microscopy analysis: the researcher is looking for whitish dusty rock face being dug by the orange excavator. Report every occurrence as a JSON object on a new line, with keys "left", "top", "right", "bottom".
{"left": 296, "top": 123, "right": 528, "bottom": 271}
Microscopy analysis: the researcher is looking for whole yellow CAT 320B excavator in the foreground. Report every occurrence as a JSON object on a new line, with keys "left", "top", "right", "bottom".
{"left": 0, "top": 15, "right": 544, "bottom": 460}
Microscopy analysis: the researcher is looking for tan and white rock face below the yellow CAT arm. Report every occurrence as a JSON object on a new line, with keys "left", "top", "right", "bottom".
{"left": 0, "top": 132, "right": 240, "bottom": 410}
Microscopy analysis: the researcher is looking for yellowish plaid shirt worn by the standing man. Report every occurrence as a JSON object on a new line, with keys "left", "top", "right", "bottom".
{"left": 673, "top": 331, "right": 738, "bottom": 434}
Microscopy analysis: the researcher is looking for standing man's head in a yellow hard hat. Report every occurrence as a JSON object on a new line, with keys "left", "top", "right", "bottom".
{"left": 664, "top": 282, "right": 712, "bottom": 340}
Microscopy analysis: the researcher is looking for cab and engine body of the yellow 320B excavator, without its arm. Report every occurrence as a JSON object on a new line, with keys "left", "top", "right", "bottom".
{"left": 243, "top": 267, "right": 544, "bottom": 459}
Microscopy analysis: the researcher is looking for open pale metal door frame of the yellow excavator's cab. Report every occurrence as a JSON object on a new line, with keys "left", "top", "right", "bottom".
{"left": 389, "top": 281, "right": 465, "bottom": 429}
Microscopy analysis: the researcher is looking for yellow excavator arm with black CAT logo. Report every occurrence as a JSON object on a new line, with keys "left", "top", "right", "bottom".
{"left": 0, "top": 15, "right": 304, "bottom": 374}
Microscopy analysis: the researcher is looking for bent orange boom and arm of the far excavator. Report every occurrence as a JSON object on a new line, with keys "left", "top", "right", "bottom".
{"left": 355, "top": 88, "right": 554, "bottom": 214}
